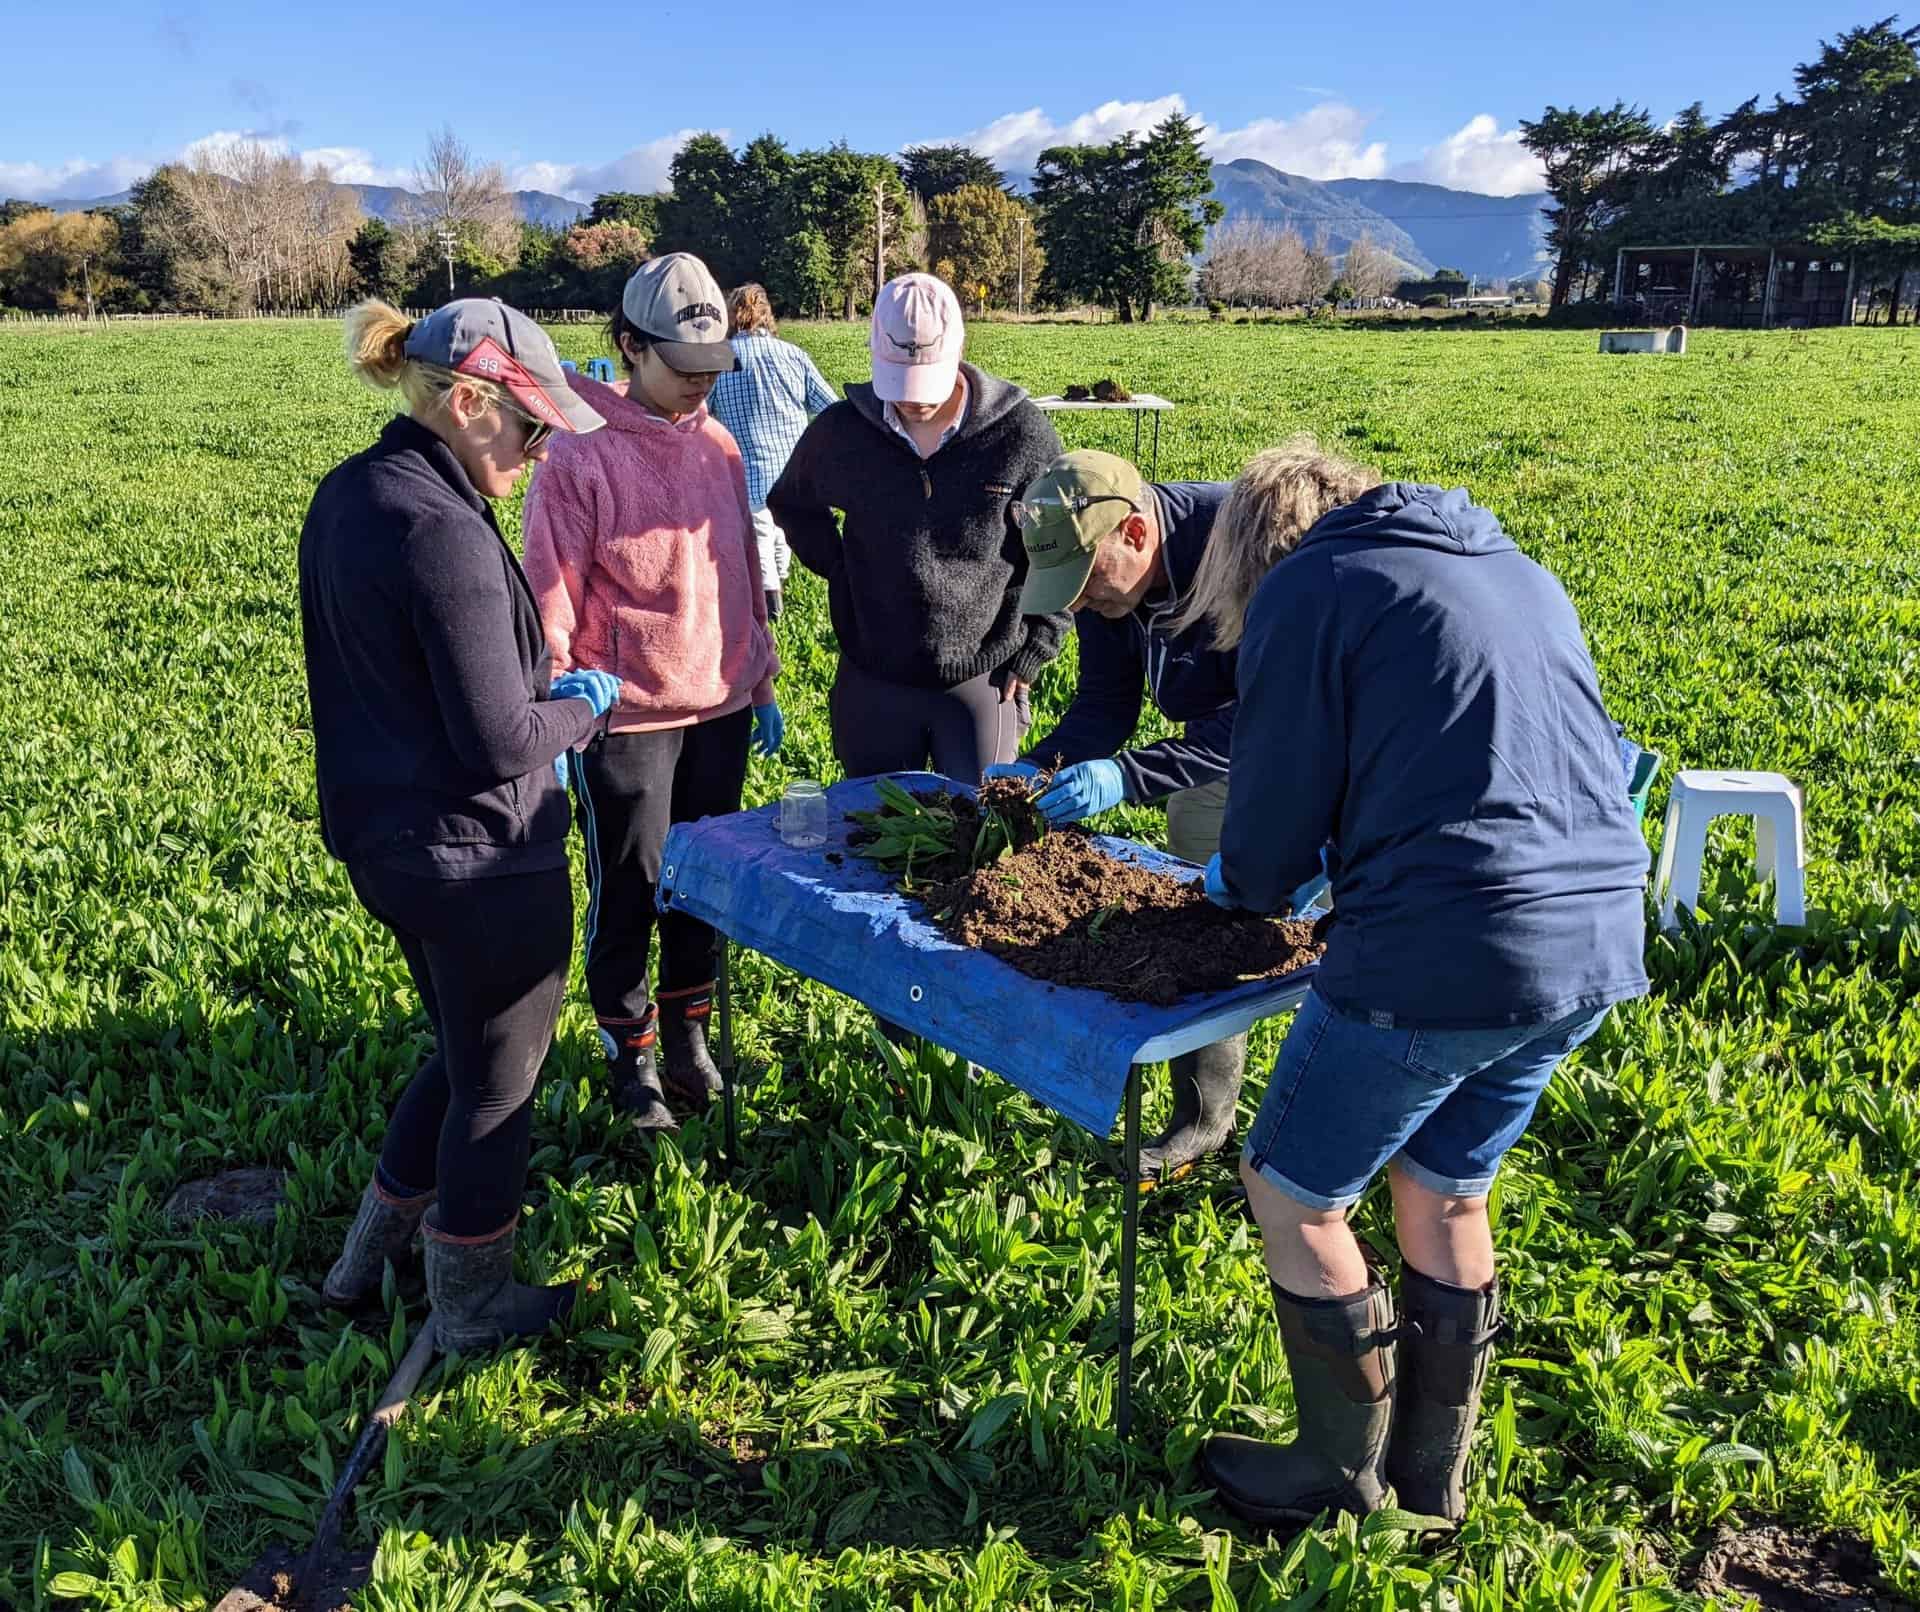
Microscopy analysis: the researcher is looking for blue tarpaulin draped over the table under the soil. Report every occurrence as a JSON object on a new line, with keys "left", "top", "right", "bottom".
{"left": 660, "top": 773, "right": 1311, "bottom": 1136}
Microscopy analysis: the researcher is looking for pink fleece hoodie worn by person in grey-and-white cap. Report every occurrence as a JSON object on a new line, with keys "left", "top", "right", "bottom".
{"left": 526, "top": 376, "right": 780, "bottom": 733}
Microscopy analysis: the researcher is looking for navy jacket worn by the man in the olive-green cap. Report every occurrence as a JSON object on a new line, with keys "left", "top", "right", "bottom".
{"left": 1027, "top": 482, "right": 1235, "bottom": 800}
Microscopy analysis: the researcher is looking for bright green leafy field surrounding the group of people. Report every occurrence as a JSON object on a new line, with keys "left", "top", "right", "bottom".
{"left": 0, "top": 324, "right": 1920, "bottom": 1612}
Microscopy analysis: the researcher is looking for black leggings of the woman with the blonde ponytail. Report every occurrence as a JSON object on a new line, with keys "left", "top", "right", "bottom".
{"left": 349, "top": 865, "right": 574, "bottom": 1238}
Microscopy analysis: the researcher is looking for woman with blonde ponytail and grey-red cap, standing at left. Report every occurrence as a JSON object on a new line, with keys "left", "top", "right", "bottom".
{"left": 300, "top": 297, "right": 618, "bottom": 1351}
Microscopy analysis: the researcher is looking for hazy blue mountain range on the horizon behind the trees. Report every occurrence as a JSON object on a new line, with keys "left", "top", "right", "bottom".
{"left": 46, "top": 157, "right": 1548, "bottom": 280}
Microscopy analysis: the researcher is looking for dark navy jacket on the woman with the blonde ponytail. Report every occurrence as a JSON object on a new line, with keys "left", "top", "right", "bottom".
{"left": 300, "top": 416, "right": 595, "bottom": 877}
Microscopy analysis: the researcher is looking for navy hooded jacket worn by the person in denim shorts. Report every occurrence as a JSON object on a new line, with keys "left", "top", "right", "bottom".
{"left": 1221, "top": 482, "right": 1647, "bottom": 1029}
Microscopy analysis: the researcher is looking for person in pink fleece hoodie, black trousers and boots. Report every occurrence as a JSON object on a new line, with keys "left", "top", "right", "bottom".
{"left": 526, "top": 251, "right": 785, "bottom": 1130}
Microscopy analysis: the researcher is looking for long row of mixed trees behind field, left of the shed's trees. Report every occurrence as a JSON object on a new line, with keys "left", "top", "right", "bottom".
{"left": 0, "top": 115, "right": 1398, "bottom": 320}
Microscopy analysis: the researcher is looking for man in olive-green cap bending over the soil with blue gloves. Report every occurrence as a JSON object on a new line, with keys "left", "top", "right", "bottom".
{"left": 987, "top": 449, "right": 1246, "bottom": 1180}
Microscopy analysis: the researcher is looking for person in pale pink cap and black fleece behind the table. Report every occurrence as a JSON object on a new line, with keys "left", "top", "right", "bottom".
{"left": 766, "top": 274, "right": 1068, "bottom": 783}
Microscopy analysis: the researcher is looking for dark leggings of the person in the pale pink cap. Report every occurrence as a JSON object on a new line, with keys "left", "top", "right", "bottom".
{"left": 828, "top": 656, "right": 1031, "bottom": 783}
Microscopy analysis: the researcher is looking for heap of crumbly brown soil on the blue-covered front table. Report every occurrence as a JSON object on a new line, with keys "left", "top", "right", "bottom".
{"left": 852, "top": 779, "right": 1325, "bottom": 1006}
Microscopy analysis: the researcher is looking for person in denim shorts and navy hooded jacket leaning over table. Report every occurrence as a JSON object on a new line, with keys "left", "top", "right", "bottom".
{"left": 1185, "top": 438, "right": 1647, "bottom": 1526}
